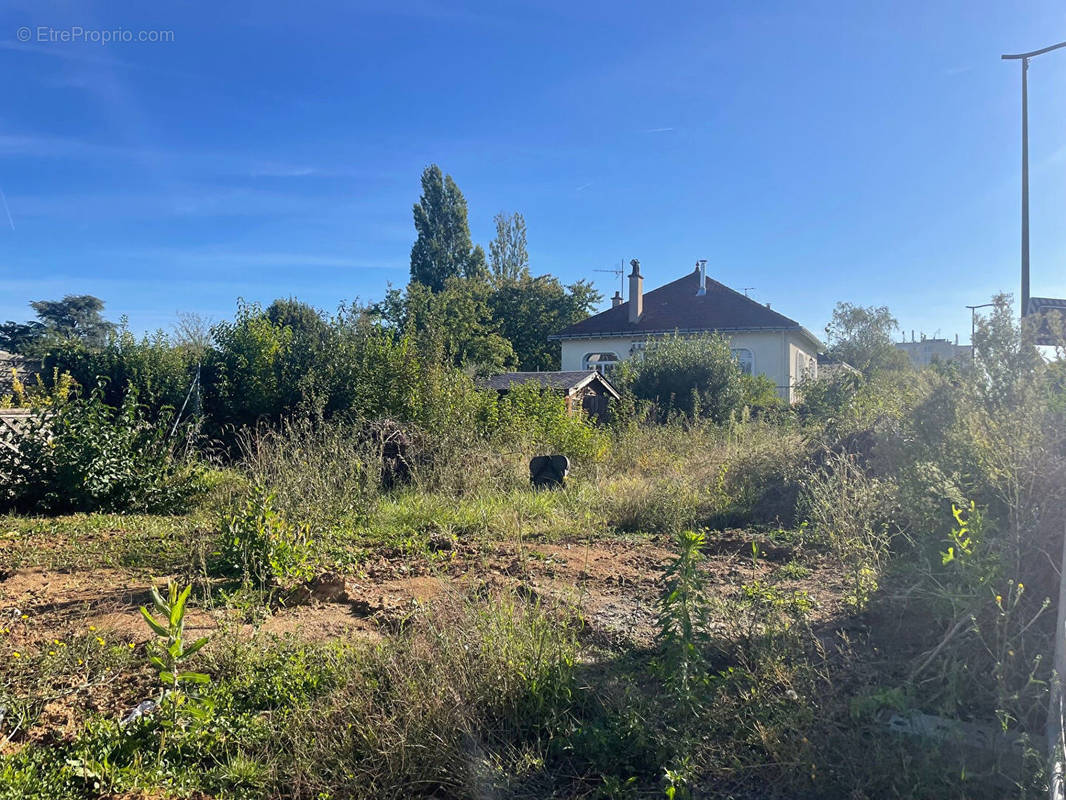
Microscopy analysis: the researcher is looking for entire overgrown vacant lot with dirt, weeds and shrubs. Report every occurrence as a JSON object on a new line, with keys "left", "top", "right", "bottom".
{"left": 0, "top": 322, "right": 1066, "bottom": 800}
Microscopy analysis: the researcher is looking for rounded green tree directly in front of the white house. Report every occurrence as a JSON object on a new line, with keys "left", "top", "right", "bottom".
{"left": 618, "top": 334, "right": 745, "bottom": 422}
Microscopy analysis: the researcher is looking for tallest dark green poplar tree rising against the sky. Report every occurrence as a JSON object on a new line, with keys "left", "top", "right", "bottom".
{"left": 410, "top": 164, "right": 487, "bottom": 291}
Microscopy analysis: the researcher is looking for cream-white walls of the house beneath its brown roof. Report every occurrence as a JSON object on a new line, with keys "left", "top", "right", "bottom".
{"left": 560, "top": 331, "right": 818, "bottom": 403}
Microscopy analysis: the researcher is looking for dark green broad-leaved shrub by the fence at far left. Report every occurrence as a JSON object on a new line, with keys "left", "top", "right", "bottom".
{"left": 0, "top": 389, "right": 201, "bottom": 514}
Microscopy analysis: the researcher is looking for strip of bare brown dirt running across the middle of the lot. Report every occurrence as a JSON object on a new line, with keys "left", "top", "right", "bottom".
{"left": 0, "top": 531, "right": 841, "bottom": 646}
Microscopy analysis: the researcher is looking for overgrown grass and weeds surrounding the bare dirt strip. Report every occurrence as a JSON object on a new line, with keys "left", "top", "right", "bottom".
{"left": 0, "top": 328, "right": 1066, "bottom": 800}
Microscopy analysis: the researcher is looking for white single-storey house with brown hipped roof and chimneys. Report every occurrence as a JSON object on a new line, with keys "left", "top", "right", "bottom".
{"left": 549, "top": 259, "right": 822, "bottom": 402}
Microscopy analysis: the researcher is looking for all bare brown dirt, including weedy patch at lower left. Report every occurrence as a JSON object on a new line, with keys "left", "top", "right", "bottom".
{"left": 0, "top": 531, "right": 843, "bottom": 768}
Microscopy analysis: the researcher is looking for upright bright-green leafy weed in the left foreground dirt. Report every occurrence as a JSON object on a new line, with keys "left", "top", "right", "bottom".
{"left": 141, "top": 580, "right": 212, "bottom": 727}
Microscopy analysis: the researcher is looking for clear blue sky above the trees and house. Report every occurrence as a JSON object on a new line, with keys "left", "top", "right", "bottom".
{"left": 0, "top": 0, "right": 1066, "bottom": 340}
